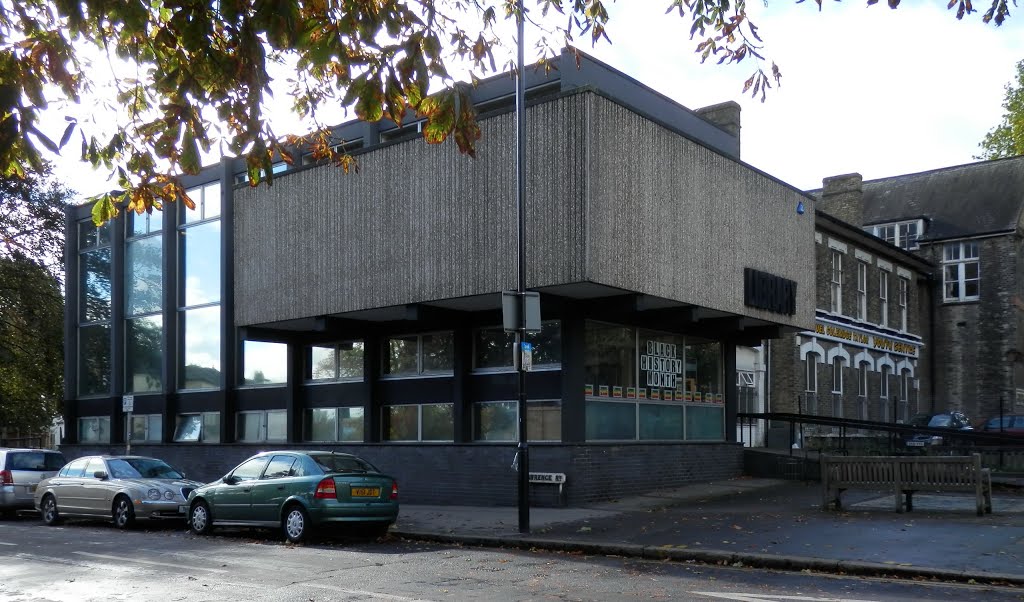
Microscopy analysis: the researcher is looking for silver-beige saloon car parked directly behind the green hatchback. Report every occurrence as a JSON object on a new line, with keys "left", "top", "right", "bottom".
{"left": 35, "top": 456, "right": 202, "bottom": 528}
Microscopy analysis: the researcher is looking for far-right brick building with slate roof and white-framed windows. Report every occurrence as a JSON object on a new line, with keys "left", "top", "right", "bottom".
{"left": 813, "top": 157, "right": 1024, "bottom": 424}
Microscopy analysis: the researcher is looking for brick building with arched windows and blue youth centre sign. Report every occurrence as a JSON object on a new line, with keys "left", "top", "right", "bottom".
{"left": 767, "top": 206, "right": 933, "bottom": 446}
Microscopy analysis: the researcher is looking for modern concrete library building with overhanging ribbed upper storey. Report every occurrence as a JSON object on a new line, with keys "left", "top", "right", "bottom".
{"left": 61, "top": 49, "right": 815, "bottom": 504}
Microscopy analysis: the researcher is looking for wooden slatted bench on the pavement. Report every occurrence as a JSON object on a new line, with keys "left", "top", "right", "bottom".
{"left": 821, "top": 454, "right": 992, "bottom": 516}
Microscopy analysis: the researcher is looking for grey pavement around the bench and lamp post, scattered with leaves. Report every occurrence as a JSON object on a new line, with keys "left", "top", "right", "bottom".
{"left": 391, "top": 477, "right": 1024, "bottom": 586}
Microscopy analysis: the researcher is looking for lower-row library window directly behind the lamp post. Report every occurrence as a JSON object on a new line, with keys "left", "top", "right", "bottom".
{"left": 473, "top": 400, "right": 562, "bottom": 441}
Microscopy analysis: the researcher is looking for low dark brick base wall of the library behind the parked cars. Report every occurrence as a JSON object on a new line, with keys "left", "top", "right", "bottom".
{"left": 60, "top": 442, "right": 743, "bottom": 506}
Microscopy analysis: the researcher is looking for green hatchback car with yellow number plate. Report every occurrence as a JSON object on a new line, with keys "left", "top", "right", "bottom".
{"left": 188, "top": 450, "right": 398, "bottom": 543}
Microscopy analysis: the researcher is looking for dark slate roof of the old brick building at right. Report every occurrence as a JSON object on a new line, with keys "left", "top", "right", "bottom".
{"left": 860, "top": 157, "right": 1024, "bottom": 240}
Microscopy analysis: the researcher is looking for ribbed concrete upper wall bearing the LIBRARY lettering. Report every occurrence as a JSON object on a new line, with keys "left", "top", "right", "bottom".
{"left": 587, "top": 96, "right": 814, "bottom": 328}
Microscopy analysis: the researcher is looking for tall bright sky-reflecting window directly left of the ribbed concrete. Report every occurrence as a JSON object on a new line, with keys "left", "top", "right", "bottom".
{"left": 178, "top": 182, "right": 221, "bottom": 389}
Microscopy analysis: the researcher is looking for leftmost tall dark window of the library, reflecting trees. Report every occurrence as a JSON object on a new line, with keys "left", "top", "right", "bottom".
{"left": 78, "top": 219, "right": 112, "bottom": 395}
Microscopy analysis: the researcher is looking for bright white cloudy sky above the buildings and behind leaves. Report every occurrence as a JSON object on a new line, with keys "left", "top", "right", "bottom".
{"left": 49, "top": 0, "right": 1024, "bottom": 195}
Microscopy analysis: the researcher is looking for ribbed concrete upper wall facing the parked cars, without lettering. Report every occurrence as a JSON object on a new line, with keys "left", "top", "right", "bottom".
{"left": 234, "top": 94, "right": 589, "bottom": 326}
